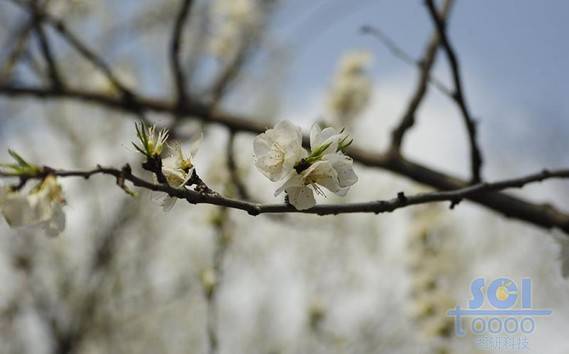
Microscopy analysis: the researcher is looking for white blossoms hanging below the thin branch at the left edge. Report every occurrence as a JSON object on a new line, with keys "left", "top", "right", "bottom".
{"left": 0, "top": 176, "right": 65, "bottom": 236}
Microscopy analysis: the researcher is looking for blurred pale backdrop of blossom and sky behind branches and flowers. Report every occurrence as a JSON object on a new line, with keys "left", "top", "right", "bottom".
{"left": 0, "top": 0, "right": 569, "bottom": 354}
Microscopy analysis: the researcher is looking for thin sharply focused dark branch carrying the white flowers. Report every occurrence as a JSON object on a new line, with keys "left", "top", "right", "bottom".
{"left": 0, "top": 165, "right": 569, "bottom": 234}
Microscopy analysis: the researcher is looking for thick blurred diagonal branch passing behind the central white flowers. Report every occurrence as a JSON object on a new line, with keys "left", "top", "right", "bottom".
{"left": 0, "top": 85, "right": 569, "bottom": 233}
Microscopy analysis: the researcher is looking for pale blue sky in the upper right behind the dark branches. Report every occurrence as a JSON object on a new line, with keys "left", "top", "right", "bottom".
{"left": 275, "top": 0, "right": 569, "bottom": 173}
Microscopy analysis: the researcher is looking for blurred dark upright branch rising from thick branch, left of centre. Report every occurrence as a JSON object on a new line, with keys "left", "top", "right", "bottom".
{"left": 170, "top": 0, "right": 193, "bottom": 107}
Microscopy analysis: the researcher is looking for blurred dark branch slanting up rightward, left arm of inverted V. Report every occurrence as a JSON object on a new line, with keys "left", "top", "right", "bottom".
{"left": 386, "top": 0, "right": 453, "bottom": 153}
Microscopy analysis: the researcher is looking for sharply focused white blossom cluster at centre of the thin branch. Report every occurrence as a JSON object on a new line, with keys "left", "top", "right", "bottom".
{"left": 253, "top": 121, "right": 358, "bottom": 210}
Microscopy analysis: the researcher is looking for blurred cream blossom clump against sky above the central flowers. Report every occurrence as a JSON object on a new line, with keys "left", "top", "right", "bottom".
{"left": 328, "top": 51, "right": 372, "bottom": 125}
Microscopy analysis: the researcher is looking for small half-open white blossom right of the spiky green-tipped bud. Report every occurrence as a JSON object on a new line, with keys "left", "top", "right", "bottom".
{"left": 161, "top": 135, "right": 203, "bottom": 211}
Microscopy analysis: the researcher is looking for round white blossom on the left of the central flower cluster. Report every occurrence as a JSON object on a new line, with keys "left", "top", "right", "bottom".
{"left": 253, "top": 121, "right": 307, "bottom": 182}
